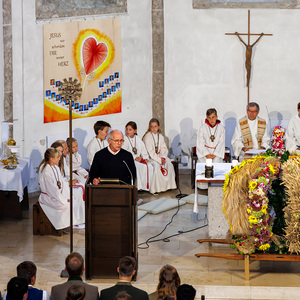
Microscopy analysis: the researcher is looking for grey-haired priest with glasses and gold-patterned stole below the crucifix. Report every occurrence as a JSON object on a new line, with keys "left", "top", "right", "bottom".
{"left": 231, "top": 102, "right": 270, "bottom": 161}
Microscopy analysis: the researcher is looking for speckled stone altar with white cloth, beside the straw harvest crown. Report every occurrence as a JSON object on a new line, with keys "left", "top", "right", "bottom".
{"left": 195, "top": 163, "right": 232, "bottom": 239}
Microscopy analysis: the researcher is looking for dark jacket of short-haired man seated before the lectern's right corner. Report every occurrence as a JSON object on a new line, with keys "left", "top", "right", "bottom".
{"left": 99, "top": 281, "right": 149, "bottom": 300}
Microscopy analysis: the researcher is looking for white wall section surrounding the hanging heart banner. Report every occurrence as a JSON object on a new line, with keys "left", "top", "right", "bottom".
{"left": 12, "top": 0, "right": 152, "bottom": 191}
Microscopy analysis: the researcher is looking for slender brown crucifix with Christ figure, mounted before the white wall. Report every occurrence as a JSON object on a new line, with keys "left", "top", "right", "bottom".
{"left": 225, "top": 10, "right": 273, "bottom": 104}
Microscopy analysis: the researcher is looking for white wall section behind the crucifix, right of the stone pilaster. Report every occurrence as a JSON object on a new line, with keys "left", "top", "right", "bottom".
{"left": 164, "top": 0, "right": 300, "bottom": 162}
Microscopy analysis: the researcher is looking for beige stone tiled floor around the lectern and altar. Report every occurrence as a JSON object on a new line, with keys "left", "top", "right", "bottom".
{"left": 0, "top": 175, "right": 300, "bottom": 300}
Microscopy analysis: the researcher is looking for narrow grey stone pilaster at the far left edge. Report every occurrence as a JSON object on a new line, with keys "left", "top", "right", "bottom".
{"left": 2, "top": 0, "right": 13, "bottom": 123}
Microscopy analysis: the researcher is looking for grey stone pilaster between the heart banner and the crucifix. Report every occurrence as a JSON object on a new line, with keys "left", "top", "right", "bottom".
{"left": 152, "top": 0, "right": 165, "bottom": 132}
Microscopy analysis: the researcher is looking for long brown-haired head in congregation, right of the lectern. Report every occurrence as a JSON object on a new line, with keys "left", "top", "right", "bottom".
{"left": 156, "top": 265, "right": 180, "bottom": 299}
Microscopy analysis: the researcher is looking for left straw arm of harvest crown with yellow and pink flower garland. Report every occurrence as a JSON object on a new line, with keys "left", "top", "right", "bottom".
{"left": 223, "top": 154, "right": 279, "bottom": 254}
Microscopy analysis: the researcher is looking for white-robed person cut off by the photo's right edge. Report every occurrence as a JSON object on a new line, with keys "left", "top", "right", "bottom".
{"left": 285, "top": 102, "right": 300, "bottom": 154}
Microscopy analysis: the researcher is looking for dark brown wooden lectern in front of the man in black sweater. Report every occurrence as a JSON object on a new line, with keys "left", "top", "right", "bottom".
{"left": 85, "top": 184, "right": 138, "bottom": 279}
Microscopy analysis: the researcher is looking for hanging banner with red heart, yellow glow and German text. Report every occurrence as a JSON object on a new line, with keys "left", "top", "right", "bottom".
{"left": 44, "top": 18, "right": 122, "bottom": 123}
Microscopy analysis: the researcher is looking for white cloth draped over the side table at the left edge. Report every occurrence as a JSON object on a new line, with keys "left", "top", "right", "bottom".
{"left": 0, "top": 158, "right": 33, "bottom": 202}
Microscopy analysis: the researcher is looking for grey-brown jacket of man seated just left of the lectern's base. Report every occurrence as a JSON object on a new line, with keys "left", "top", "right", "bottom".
{"left": 51, "top": 278, "right": 99, "bottom": 300}
